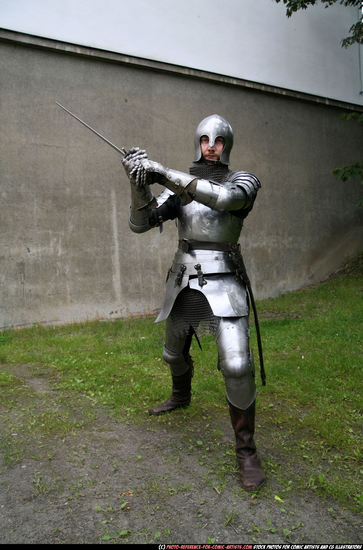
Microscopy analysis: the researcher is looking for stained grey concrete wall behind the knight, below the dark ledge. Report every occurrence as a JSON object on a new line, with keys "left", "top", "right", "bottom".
{"left": 0, "top": 33, "right": 363, "bottom": 327}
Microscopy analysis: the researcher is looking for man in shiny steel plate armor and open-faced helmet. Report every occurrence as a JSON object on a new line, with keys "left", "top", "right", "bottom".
{"left": 123, "top": 114, "right": 266, "bottom": 491}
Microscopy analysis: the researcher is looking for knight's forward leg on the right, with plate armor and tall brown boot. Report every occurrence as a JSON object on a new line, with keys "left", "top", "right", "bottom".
{"left": 216, "top": 317, "right": 266, "bottom": 491}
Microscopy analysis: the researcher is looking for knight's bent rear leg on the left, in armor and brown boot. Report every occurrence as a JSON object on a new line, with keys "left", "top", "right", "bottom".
{"left": 149, "top": 319, "right": 193, "bottom": 415}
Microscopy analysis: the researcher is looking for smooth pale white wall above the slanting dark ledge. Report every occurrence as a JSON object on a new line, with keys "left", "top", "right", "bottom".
{"left": 0, "top": 0, "right": 363, "bottom": 106}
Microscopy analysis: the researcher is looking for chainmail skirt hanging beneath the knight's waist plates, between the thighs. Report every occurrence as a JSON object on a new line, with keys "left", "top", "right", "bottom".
{"left": 170, "top": 287, "right": 220, "bottom": 336}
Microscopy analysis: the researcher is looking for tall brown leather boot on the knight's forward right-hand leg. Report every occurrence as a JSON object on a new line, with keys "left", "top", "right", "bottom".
{"left": 228, "top": 401, "right": 266, "bottom": 491}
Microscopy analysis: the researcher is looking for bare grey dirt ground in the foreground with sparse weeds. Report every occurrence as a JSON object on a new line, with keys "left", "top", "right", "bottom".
{"left": 0, "top": 365, "right": 361, "bottom": 544}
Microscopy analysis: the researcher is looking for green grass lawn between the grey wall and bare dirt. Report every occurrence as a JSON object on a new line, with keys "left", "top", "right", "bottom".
{"left": 0, "top": 254, "right": 363, "bottom": 507}
